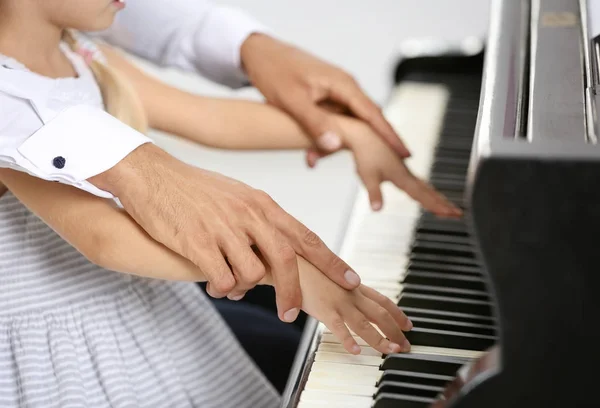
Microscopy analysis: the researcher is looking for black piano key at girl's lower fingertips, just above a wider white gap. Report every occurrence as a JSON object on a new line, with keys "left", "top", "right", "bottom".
{"left": 404, "top": 324, "right": 497, "bottom": 351}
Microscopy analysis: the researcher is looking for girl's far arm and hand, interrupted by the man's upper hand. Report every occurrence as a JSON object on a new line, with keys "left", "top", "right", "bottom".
{"left": 102, "top": 47, "right": 461, "bottom": 216}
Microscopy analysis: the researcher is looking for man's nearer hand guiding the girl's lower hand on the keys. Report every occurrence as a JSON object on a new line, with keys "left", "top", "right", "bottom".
{"left": 90, "top": 144, "right": 360, "bottom": 322}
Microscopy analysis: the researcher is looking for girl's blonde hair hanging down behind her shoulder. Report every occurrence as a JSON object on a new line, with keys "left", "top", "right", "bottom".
{"left": 63, "top": 30, "right": 148, "bottom": 133}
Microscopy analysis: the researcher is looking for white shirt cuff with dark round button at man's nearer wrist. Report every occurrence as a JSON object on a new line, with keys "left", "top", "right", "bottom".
{"left": 17, "top": 105, "right": 152, "bottom": 198}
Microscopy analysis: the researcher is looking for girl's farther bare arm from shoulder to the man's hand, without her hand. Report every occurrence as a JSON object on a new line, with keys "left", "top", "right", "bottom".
{"left": 101, "top": 46, "right": 311, "bottom": 150}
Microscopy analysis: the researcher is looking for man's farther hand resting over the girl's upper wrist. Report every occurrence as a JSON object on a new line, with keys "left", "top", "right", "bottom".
{"left": 241, "top": 34, "right": 410, "bottom": 166}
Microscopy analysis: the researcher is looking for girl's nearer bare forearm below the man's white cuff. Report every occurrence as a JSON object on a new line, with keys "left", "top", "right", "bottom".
{"left": 0, "top": 169, "right": 217, "bottom": 281}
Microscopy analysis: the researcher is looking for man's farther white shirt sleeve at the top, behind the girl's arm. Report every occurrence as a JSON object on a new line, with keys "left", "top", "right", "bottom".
{"left": 94, "top": 0, "right": 270, "bottom": 88}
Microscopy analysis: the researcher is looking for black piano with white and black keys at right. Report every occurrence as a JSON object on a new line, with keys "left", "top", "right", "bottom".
{"left": 283, "top": 0, "right": 600, "bottom": 408}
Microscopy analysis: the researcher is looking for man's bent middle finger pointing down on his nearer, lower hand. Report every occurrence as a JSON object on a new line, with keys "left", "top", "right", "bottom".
{"left": 252, "top": 224, "right": 302, "bottom": 323}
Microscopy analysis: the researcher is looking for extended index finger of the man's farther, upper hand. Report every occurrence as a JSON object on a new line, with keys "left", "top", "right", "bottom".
{"left": 330, "top": 81, "right": 410, "bottom": 158}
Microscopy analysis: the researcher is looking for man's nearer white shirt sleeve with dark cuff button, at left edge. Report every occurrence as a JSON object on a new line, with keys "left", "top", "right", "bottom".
{"left": 0, "top": 93, "right": 152, "bottom": 198}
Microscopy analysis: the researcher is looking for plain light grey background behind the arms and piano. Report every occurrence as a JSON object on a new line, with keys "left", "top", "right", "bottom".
{"left": 138, "top": 0, "right": 489, "bottom": 251}
